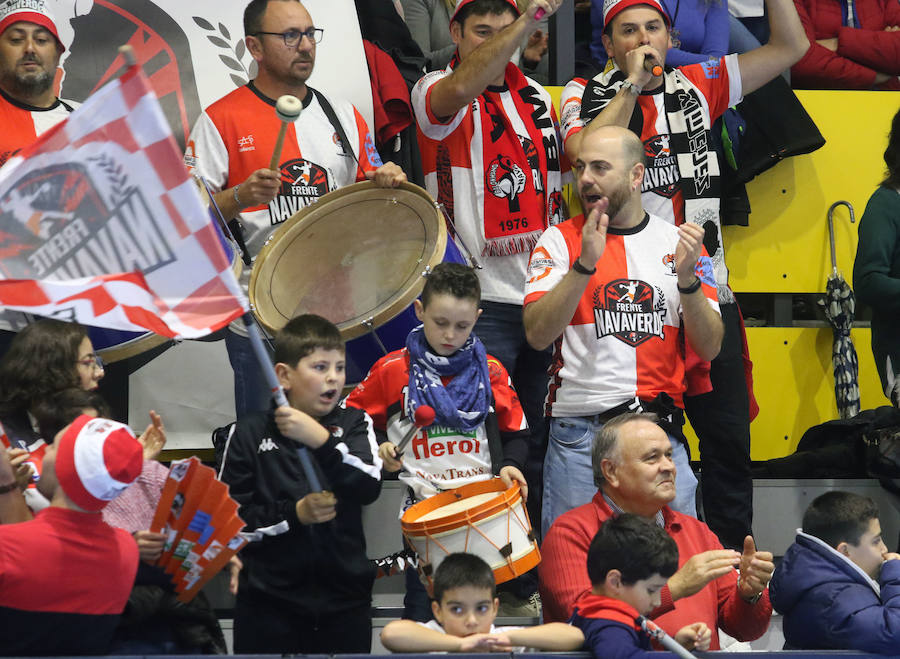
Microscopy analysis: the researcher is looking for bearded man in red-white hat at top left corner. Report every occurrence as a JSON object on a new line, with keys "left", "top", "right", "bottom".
{"left": 0, "top": 0, "right": 77, "bottom": 165}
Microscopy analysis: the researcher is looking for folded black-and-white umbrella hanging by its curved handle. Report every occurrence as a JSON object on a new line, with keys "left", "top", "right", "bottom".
{"left": 819, "top": 201, "right": 859, "bottom": 419}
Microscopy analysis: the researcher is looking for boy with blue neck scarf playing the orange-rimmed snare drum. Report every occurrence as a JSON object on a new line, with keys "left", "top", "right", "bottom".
{"left": 347, "top": 263, "right": 529, "bottom": 622}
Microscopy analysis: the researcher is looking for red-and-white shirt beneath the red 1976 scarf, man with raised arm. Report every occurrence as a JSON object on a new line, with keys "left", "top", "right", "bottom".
{"left": 411, "top": 67, "right": 568, "bottom": 304}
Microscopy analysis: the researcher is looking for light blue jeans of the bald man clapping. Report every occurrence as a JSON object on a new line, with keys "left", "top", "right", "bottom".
{"left": 541, "top": 416, "right": 697, "bottom": 536}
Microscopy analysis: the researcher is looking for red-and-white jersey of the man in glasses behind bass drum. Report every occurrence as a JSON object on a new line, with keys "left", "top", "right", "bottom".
{"left": 184, "top": 83, "right": 382, "bottom": 318}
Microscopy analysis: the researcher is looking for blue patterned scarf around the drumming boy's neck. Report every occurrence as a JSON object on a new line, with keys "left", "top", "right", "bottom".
{"left": 406, "top": 325, "right": 491, "bottom": 431}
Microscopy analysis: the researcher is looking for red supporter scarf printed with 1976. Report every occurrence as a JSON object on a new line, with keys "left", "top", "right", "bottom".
{"left": 449, "top": 53, "right": 561, "bottom": 256}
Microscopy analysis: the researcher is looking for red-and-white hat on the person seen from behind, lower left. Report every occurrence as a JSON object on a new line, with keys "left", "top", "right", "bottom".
{"left": 56, "top": 414, "right": 144, "bottom": 511}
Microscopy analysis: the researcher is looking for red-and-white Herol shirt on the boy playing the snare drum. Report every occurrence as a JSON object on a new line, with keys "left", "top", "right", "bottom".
{"left": 347, "top": 348, "right": 528, "bottom": 513}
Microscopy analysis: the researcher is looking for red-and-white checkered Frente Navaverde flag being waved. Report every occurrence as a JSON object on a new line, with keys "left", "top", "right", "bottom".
{"left": 0, "top": 66, "right": 248, "bottom": 339}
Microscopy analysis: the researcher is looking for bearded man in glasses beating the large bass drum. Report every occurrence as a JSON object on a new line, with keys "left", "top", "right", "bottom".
{"left": 185, "top": 0, "right": 406, "bottom": 418}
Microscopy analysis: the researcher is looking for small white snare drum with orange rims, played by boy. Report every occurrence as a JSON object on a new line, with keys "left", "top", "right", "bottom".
{"left": 400, "top": 478, "right": 541, "bottom": 593}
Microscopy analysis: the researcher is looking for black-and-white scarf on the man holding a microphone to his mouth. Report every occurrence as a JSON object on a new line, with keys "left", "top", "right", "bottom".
{"left": 581, "top": 65, "right": 734, "bottom": 303}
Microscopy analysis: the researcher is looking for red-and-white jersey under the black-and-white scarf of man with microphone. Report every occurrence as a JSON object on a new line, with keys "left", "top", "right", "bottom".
{"left": 560, "top": 55, "right": 743, "bottom": 224}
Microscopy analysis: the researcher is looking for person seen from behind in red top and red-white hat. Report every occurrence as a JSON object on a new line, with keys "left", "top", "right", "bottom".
{"left": 0, "top": 414, "right": 143, "bottom": 656}
